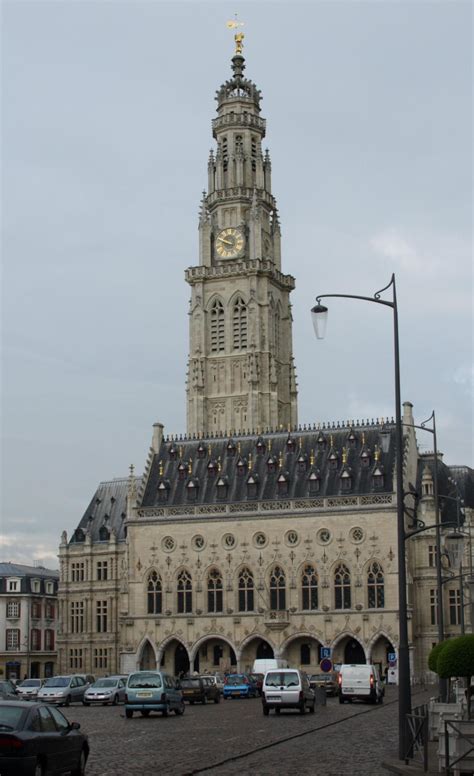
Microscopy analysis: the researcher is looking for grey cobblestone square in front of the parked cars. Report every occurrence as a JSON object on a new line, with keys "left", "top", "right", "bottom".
{"left": 65, "top": 687, "right": 430, "bottom": 776}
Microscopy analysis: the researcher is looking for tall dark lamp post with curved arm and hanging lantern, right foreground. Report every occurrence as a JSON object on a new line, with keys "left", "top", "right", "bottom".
{"left": 311, "top": 274, "right": 411, "bottom": 760}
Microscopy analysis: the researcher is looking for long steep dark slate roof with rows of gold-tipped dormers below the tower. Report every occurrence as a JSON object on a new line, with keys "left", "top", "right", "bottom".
{"left": 140, "top": 423, "right": 395, "bottom": 507}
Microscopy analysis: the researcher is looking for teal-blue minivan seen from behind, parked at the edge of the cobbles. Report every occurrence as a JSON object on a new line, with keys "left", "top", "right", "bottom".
{"left": 125, "top": 671, "right": 185, "bottom": 719}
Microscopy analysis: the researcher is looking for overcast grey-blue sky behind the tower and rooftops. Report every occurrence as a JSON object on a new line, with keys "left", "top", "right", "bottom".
{"left": 0, "top": 0, "right": 473, "bottom": 566}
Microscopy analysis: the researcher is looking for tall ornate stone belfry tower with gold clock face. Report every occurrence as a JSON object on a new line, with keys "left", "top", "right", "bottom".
{"left": 186, "top": 51, "right": 297, "bottom": 434}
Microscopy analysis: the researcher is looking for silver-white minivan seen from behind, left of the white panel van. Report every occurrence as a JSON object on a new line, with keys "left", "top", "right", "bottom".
{"left": 262, "top": 668, "right": 316, "bottom": 717}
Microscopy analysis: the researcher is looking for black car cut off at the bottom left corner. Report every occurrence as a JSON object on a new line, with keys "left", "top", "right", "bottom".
{"left": 0, "top": 700, "right": 89, "bottom": 776}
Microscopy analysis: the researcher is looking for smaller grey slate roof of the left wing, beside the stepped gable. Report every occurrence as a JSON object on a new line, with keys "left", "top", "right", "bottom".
{"left": 71, "top": 477, "right": 139, "bottom": 544}
